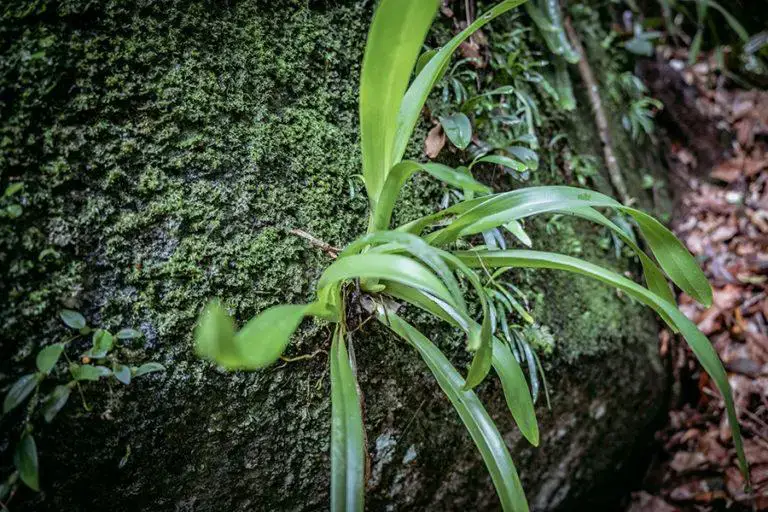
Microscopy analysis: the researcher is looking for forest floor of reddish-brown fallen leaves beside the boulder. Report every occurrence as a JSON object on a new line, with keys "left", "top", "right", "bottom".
{"left": 628, "top": 46, "right": 768, "bottom": 512}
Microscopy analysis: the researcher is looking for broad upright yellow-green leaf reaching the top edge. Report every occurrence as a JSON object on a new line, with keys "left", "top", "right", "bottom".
{"left": 360, "top": 0, "right": 438, "bottom": 204}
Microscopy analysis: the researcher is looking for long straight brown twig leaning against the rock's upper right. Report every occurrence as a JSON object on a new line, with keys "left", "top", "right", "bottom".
{"left": 565, "top": 18, "right": 632, "bottom": 205}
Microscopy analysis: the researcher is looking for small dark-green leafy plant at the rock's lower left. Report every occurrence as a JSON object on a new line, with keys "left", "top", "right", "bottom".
{"left": 0, "top": 309, "right": 165, "bottom": 510}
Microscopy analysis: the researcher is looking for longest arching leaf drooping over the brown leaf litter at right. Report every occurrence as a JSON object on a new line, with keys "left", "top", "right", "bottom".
{"left": 456, "top": 250, "right": 749, "bottom": 481}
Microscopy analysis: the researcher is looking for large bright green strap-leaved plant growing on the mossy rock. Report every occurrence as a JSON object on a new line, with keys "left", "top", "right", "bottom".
{"left": 195, "top": 0, "right": 748, "bottom": 511}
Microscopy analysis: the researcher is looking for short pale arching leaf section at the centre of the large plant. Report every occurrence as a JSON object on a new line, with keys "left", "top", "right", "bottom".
{"left": 318, "top": 253, "right": 454, "bottom": 304}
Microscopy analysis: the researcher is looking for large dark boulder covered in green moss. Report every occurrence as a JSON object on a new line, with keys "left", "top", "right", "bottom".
{"left": 0, "top": 0, "right": 665, "bottom": 511}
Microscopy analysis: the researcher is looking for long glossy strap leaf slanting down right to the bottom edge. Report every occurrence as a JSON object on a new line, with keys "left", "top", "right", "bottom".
{"left": 378, "top": 309, "right": 528, "bottom": 512}
